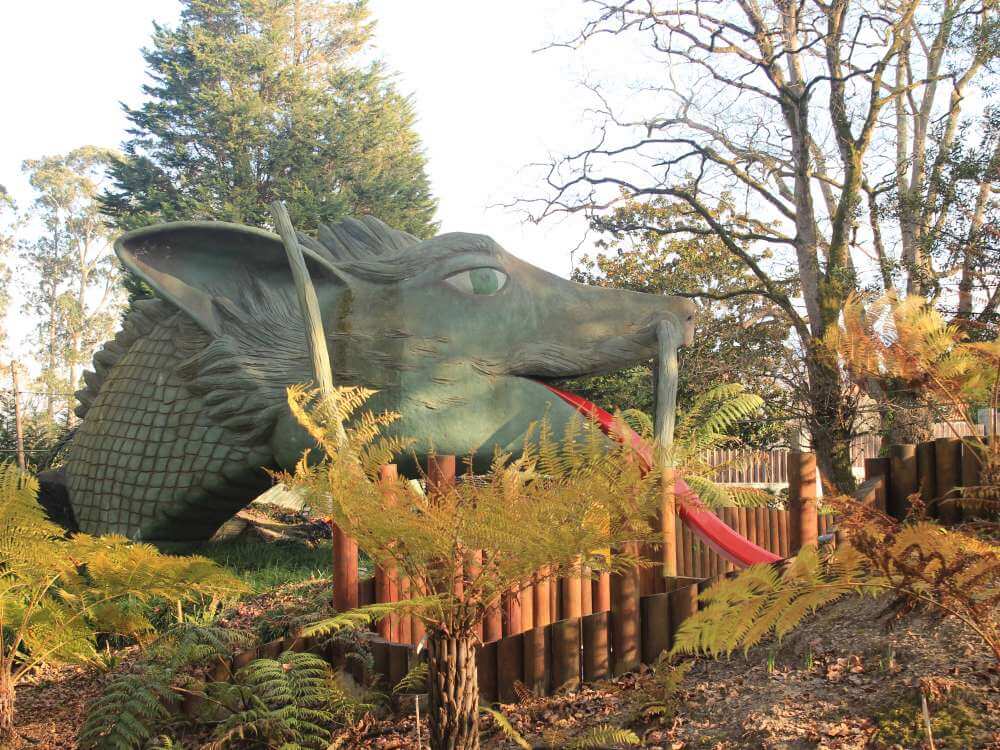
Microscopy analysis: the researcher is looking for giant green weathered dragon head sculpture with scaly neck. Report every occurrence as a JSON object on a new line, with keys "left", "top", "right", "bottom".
{"left": 58, "top": 217, "right": 693, "bottom": 540}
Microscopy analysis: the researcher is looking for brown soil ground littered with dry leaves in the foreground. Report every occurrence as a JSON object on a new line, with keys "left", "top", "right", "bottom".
{"left": 9, "top": 599, "right": 1000, "bottom": 750}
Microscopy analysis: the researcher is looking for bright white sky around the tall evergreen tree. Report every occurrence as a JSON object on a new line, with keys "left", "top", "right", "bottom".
{"left": 0, "top": 0, "right": 664, "bottom": 362}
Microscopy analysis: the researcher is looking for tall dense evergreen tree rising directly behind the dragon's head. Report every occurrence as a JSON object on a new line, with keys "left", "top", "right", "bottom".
{"left": 102, "top": 0, "right": 436, "bottom": 258}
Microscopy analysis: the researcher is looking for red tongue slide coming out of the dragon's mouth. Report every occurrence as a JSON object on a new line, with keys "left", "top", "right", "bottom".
{"left": 545, "top": 385, "right": 781, "bottom": 568}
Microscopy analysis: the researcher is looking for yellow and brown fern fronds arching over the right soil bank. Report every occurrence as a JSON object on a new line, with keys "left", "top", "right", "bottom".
{"left": 673, "top": 516, "right": 1000, "bottom": 663}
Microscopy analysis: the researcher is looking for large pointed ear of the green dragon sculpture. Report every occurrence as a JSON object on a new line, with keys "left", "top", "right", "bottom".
{"left": 115, "top": 221, "right": 347, "bottom": 334}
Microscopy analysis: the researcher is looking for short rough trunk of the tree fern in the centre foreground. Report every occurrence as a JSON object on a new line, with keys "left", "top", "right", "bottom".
{"left": 427, "top": 630, "right": 479, "bottom": 750}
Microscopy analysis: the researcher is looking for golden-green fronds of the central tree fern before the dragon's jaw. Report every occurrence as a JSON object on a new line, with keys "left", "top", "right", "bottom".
{"left": 276, "top": 386, "right": 776, "bottom": 748}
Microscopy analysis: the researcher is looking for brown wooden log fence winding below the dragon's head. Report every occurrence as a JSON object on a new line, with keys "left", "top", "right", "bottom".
{"left": 199, "top": 438, "right": 979, "bottom": 702}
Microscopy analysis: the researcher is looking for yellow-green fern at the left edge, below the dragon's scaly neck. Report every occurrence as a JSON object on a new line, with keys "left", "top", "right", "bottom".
{"left": 0, "top": 464, "right": 245, "bottom": 736}
